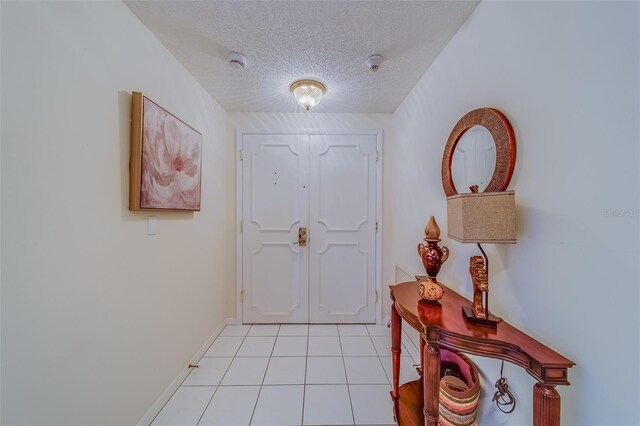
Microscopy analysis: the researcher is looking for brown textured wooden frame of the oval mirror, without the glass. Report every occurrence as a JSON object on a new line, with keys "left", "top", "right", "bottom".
{"left": 442, "top": 108, "right": 516, "bottom": 197}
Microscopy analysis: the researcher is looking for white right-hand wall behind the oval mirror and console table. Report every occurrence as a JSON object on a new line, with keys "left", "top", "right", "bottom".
{"left": 387, "top": 2, "right": 640, "bottom": 426}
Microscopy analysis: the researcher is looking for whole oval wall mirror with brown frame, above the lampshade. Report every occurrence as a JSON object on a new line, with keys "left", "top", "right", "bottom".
{"left": 442, "top": 108, "right": 516, "bottom": 197}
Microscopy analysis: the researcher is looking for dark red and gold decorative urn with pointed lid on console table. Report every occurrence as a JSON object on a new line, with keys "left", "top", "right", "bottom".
{"left": 418, "top": 216, "right": 449, "bottom": 301}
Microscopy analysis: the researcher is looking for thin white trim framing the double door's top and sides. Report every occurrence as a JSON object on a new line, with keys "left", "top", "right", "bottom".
{"left": 235, "top": 128, "right": 384, "bottom": 324}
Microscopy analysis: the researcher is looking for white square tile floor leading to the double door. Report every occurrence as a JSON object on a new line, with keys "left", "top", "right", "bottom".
{"left": 152, "top": 324, "right": 418, "bottom": 426}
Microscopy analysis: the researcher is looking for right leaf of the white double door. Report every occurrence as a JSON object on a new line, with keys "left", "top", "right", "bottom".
{"left": 309, "top": 135, "right": 377, "bottom": 323}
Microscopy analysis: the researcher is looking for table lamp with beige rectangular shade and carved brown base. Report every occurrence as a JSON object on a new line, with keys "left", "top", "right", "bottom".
{"left": 447, "top": 187, "right": 516, "bottom": 328}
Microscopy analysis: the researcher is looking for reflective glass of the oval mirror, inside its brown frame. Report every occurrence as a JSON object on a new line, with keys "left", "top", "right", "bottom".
{"left": 451, "top": 126, "right": 496, "bottom": 192}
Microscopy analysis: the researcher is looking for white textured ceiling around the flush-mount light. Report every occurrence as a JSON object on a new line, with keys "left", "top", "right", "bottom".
{"left": 126, "top": 0, "right": 478, "bottom": 112}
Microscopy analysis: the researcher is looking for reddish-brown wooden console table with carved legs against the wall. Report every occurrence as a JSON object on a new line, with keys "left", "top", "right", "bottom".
{"left": 390, "top": 277, "right": 575, "bottom": 426}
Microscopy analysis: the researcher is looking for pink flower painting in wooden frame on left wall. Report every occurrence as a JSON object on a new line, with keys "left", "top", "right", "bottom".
{"left": 129, "top": 92, "right": 202, "bottom": 211}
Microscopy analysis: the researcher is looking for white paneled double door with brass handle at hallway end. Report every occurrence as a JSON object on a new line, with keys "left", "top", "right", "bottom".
{"left": 239, "top": 133, "right": 378, "bottom": 323}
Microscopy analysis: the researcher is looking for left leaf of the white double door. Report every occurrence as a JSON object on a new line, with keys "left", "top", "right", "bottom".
{"left": 242, "top": 134, "right": 309, "bottom": 322}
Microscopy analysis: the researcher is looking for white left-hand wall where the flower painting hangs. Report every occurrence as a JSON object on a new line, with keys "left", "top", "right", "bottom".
{"left": 1, "top": 2, "right": 233, "bottom": 426}
